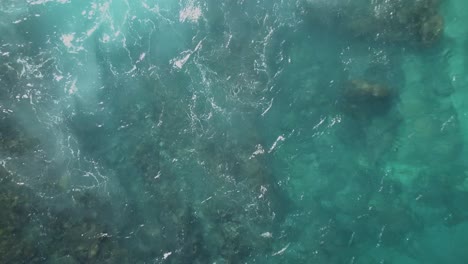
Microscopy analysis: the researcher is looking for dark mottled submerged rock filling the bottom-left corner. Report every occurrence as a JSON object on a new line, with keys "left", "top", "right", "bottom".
{"left": 0, "top": 166, "right": 125, "bottom": 263}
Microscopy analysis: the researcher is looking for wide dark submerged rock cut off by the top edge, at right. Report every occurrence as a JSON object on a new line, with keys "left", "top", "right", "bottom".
{"left": 307, "top": 0, "right": 444, "bottom": 46}
